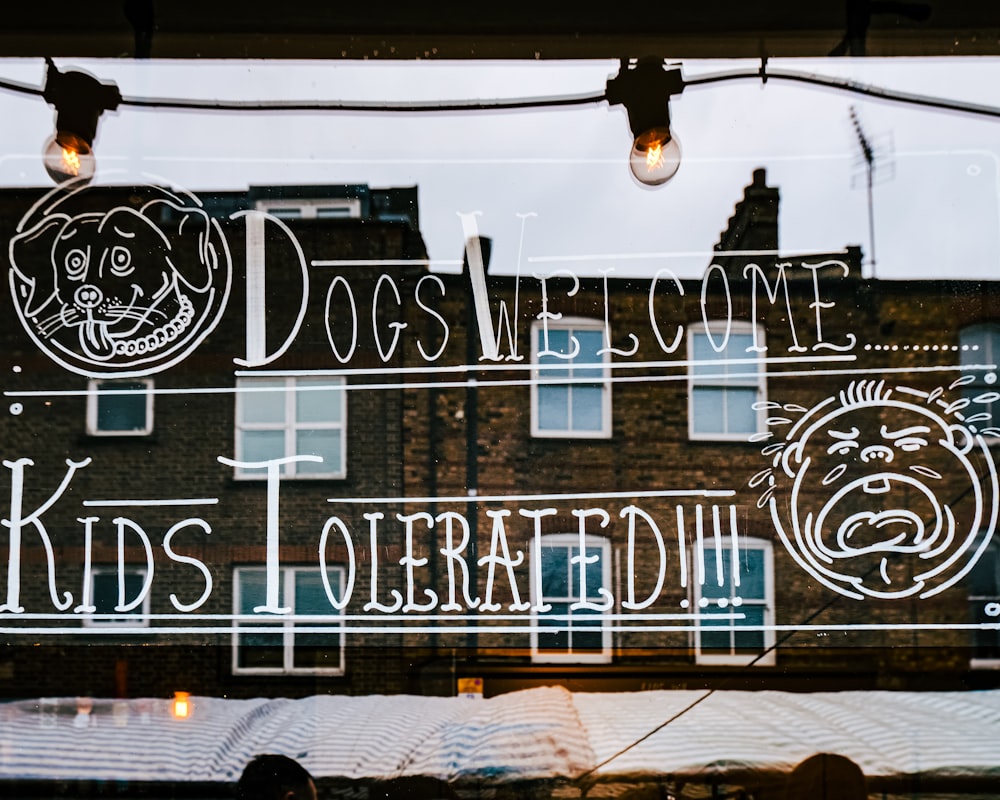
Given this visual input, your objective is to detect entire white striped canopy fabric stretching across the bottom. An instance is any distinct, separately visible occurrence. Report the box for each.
[0,687,1000,783]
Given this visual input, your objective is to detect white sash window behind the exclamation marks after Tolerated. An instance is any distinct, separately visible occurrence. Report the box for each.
[689,536,777,667]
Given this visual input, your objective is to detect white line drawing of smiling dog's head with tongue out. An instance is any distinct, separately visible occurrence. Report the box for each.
[10,187,229,374]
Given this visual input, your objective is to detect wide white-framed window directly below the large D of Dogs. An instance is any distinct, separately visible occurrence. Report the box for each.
[233,375,348,481]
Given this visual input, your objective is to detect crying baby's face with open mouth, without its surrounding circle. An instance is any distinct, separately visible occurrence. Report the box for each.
[783,401,976,595]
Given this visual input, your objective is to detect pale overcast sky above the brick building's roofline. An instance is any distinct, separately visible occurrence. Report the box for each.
[0,58,1000,279]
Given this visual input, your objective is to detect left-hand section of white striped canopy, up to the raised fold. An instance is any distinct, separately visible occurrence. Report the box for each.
[0,688,593,782]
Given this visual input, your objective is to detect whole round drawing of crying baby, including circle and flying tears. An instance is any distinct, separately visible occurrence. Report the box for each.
[751,381,997,598]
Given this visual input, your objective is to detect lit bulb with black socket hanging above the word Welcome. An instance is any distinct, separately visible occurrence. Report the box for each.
[605,59,684,186]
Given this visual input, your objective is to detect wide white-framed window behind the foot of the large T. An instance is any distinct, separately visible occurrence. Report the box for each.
[231,565,346,677]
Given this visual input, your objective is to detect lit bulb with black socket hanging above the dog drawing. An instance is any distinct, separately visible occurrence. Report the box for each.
[42,61,121,183]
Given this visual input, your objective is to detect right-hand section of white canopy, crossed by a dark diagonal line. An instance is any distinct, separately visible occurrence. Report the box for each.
[573,691,1000,782]
